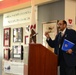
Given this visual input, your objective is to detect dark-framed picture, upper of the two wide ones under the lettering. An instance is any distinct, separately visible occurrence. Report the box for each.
[13,27,23,42]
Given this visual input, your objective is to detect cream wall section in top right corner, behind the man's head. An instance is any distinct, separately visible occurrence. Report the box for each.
[64,0,76,30]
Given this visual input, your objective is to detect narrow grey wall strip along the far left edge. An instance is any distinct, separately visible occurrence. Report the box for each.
[0,15,3,75]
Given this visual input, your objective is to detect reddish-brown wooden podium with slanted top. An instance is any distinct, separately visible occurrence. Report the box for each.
[28,44,58,75]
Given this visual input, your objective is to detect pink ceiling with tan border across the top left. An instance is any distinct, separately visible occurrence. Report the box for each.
[0,0,58,14]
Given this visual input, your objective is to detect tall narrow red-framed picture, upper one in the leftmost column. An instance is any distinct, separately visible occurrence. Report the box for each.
[4,28,11,47]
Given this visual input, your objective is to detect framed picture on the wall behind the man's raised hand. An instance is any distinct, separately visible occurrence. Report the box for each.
[43,21,57,47]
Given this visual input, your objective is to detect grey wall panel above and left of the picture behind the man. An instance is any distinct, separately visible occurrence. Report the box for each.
[38,0,64,43]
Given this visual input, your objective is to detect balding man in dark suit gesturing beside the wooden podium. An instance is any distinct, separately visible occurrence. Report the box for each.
[45,20,76,75]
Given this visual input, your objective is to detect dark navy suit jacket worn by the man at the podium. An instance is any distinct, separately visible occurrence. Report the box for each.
[46,29,76,66]
